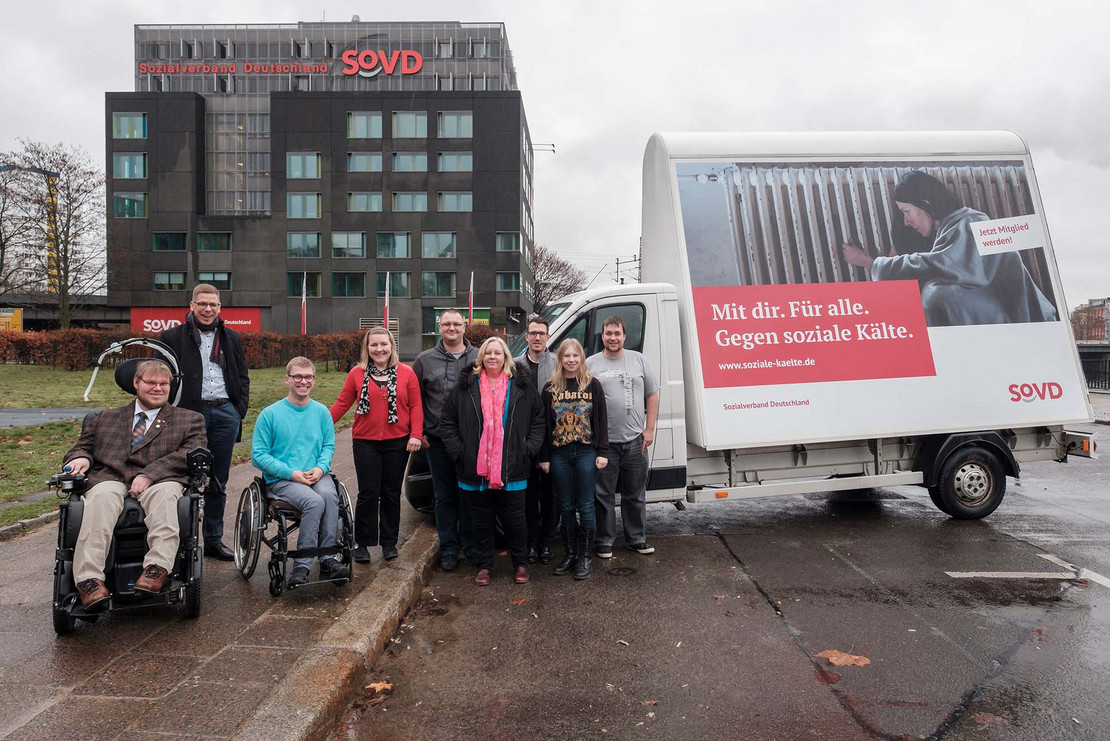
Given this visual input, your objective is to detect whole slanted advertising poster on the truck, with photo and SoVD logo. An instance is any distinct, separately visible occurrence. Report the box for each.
[675,160,1088,448]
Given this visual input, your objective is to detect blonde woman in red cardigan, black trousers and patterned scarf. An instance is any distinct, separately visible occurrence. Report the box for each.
[332,327,424,564]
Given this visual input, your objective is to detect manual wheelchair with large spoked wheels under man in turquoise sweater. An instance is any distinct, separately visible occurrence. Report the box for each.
[234,474,354,597]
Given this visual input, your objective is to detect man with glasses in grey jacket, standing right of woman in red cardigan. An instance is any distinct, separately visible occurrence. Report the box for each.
[413,308,478,571]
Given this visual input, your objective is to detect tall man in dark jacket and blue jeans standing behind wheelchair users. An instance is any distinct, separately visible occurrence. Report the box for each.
[159,283,251,561]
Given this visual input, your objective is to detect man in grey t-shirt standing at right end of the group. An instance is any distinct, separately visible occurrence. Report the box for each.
[586,316,659,558]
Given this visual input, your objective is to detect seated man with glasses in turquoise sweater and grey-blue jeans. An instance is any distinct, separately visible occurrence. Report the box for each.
[251,357,347,587]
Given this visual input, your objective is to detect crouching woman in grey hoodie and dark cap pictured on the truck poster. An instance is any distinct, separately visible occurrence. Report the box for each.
[840,170,1058,327]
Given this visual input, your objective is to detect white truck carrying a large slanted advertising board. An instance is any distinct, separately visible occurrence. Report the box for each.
[523,132,1094,519]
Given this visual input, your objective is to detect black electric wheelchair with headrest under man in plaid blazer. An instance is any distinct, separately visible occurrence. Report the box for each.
[48,338,212,636]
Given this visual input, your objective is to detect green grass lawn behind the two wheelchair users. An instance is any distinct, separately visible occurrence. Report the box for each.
[0,365,351,526]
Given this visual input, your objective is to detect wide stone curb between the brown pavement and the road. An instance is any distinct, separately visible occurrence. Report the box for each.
[233,514,440,741]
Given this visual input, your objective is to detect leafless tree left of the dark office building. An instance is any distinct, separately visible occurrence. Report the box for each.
[9,140,105,329]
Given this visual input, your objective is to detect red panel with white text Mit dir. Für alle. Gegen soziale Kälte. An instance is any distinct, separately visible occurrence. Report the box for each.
[694,281,936,388]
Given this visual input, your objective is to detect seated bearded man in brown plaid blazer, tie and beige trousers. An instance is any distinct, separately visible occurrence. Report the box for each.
[63,361,208,608]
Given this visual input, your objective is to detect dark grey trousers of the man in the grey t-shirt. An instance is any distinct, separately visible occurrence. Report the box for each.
[594,435,647,548]
